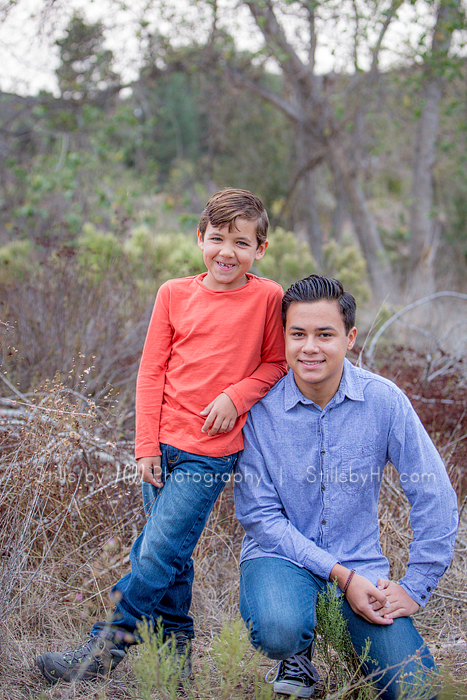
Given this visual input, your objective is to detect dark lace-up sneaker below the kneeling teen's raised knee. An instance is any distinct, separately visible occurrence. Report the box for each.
[266,644,319,698]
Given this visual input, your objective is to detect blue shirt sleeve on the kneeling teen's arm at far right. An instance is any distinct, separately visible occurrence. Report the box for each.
[388,393,457,606]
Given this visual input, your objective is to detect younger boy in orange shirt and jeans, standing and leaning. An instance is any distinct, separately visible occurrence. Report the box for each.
[37,188,286,683]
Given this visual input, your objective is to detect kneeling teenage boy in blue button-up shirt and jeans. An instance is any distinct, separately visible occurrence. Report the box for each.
[235,275,457,700]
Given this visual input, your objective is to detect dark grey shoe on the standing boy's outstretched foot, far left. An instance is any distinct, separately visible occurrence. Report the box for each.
[36,635,126,683]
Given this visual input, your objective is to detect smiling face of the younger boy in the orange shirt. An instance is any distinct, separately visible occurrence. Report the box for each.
[198,218,268,291]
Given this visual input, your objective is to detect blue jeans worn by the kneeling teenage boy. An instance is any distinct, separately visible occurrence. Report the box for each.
[240,557,436,700]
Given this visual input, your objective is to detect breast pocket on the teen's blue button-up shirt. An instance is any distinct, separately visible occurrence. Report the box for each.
[339,443,383,496]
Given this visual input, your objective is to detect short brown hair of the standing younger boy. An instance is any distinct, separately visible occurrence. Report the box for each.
[198,187,269,245]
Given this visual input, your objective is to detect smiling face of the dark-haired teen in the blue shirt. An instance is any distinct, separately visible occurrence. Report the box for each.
[285,299,357,408]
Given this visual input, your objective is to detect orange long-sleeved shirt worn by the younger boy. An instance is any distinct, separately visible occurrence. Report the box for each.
[135,273,286,459]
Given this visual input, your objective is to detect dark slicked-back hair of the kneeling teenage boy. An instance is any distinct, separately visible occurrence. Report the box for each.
[282,275,357,335]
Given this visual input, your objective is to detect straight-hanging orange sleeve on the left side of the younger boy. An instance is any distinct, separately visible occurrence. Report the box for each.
[135,285,173,460]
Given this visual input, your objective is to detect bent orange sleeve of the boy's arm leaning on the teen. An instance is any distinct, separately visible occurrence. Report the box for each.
[223,288,287,416]
